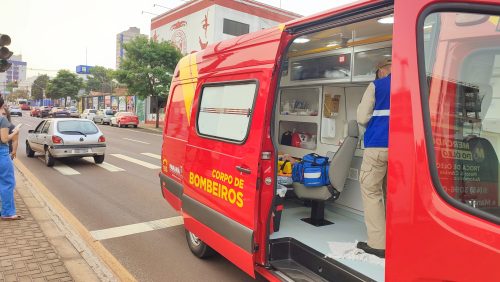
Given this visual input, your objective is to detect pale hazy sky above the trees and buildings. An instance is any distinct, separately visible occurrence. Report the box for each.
[0,0,354,77]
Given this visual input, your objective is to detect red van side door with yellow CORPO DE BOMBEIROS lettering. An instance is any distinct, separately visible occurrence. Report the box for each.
[182,28,290,277]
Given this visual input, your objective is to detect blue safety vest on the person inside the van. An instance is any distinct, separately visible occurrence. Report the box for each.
[364,75,391,148]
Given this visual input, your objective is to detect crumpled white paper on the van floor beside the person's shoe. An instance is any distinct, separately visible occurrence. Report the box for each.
[326,241,385,267]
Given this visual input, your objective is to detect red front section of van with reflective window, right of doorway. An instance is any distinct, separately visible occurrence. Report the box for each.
[386,0,500,281]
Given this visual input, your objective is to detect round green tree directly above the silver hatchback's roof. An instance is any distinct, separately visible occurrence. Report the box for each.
[46,70,83,106]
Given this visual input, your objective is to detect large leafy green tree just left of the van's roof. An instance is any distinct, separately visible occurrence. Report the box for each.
[116,36,182,128]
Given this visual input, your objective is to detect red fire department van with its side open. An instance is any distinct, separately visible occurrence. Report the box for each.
[160,0,500,281]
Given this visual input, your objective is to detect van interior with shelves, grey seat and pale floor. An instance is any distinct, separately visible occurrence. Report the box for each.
[269,13,393,281]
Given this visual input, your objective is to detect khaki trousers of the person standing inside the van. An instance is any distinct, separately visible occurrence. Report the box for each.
[359,148,387,249]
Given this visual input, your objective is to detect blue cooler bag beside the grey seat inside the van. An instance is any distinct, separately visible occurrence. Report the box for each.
[292,153,330,187]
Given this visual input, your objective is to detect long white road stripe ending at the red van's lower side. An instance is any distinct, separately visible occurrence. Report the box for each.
[90,216,184,241]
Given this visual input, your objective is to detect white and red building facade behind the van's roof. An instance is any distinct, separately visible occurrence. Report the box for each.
[151,0,301,54]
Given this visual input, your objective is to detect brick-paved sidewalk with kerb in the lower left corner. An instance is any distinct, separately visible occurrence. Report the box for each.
[0,169,100,282]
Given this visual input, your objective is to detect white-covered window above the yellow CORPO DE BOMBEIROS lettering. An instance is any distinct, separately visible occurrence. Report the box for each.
[197,81,257,143]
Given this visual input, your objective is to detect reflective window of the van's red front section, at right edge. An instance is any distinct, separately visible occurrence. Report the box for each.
[420,9,500,222]
